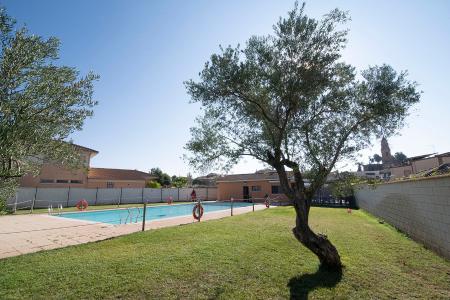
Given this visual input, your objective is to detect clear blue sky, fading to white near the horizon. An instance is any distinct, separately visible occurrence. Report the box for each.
[0,0,450,175]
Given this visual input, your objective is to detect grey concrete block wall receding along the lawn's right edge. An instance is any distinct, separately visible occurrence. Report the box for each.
[355,176,450,259]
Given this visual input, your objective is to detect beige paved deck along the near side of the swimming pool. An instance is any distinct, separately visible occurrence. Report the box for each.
[0,205,265,259]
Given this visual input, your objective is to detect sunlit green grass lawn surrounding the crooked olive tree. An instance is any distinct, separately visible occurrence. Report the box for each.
[0,207,450,299]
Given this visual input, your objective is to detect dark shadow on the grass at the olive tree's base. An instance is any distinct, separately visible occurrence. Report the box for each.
[287,268,342,299]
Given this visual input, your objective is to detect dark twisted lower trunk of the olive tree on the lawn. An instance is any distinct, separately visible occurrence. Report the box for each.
[292,213,342,270]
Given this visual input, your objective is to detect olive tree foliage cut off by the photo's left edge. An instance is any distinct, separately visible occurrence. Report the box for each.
[0,7,97,204]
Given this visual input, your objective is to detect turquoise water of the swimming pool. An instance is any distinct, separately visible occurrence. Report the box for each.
[60,202,252,224]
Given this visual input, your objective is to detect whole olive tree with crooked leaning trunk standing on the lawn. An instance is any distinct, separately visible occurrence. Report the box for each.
[185,4,420,269]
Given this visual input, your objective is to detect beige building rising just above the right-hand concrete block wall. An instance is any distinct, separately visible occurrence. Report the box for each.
[390,152,450,178]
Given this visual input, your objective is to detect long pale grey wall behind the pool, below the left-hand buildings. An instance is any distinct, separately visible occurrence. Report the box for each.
[8,187,217,211]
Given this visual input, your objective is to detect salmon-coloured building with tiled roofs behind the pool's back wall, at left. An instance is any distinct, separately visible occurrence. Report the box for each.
[20,144,154,188]
